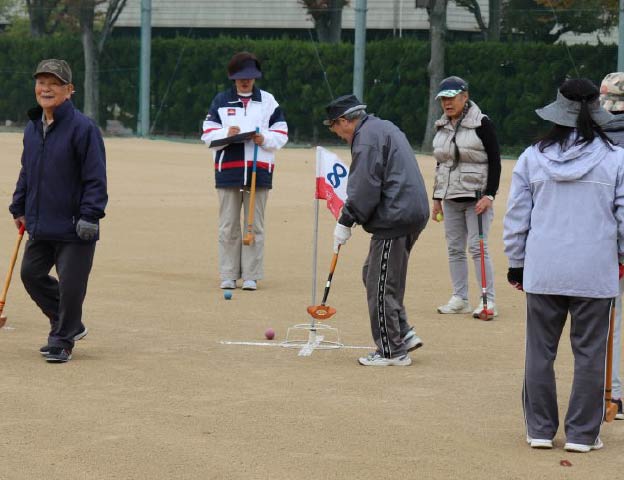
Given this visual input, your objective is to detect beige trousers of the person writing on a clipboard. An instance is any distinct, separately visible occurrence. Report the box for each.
[217,187,269,280]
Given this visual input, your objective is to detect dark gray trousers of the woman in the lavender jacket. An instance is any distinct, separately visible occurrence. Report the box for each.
[523,293,612,445]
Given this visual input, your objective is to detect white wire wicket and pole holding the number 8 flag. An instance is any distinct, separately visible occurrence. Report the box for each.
[282,154,343,357]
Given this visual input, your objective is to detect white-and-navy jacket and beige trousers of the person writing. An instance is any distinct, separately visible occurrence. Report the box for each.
[201,87,288,280]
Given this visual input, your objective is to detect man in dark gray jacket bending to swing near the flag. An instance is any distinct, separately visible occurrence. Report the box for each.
[324,95,429,366]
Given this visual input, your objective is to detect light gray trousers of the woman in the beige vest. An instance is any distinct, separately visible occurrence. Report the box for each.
[444,200,495,302]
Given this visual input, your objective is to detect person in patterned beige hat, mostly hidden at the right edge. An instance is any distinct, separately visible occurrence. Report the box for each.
[600,72,624,420]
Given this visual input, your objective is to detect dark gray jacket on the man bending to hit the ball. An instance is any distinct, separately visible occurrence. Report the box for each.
[339,115,429,239]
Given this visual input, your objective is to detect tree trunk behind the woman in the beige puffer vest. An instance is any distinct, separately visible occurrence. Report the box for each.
[422,0,448,152]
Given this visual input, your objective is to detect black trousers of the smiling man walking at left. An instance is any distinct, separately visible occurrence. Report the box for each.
[20,239,95,349]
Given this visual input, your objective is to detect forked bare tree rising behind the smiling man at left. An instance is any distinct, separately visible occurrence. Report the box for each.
[66,0,127,123]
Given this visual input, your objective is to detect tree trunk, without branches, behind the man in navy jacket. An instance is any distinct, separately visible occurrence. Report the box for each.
[79,0,100,124]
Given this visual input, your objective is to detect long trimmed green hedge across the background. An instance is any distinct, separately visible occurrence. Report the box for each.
[0,35,617,147]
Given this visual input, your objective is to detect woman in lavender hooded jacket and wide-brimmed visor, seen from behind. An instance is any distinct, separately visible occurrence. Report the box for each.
[503,79,624,452]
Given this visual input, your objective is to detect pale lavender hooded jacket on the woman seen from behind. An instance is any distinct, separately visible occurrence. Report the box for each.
[503,138,624,298]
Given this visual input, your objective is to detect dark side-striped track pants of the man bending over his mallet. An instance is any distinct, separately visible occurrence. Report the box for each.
[362,233,418,358]
